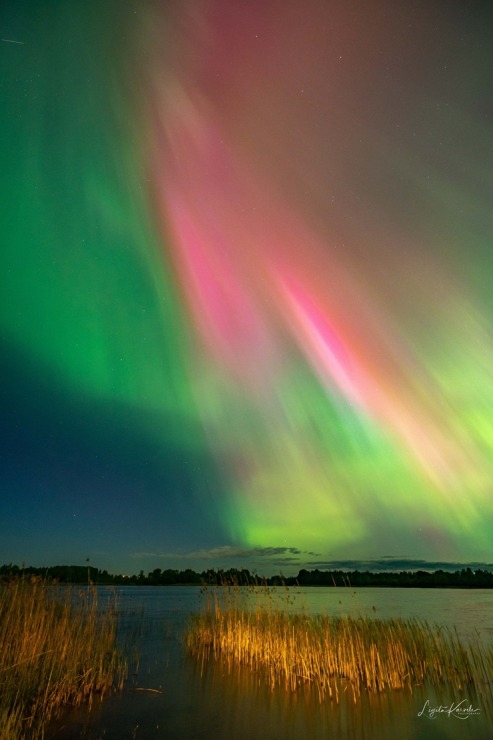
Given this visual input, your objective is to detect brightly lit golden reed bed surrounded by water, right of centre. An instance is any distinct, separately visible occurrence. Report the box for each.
[186,587,493,703]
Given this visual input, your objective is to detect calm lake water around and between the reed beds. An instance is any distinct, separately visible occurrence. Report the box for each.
[49,586,493,740]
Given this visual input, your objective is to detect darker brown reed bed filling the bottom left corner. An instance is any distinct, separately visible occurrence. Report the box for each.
[0,577,125,740]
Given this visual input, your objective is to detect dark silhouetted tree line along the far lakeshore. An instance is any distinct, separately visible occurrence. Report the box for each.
[0,563,493,588]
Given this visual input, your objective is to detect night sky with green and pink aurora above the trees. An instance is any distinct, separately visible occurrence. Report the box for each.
[0,0,493,575]
